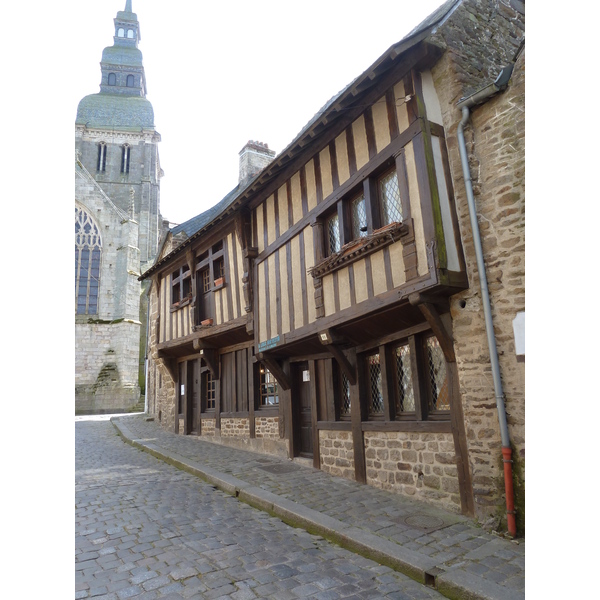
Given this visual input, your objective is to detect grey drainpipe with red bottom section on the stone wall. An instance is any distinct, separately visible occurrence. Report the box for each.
[457,58,520,537]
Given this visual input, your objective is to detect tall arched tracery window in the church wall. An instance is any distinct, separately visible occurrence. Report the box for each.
[75,206,102,315]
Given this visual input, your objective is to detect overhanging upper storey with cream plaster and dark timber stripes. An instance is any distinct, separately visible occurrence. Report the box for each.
[143,0,496,354]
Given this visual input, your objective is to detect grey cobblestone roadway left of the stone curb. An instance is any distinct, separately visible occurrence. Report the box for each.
[75,419,442,600]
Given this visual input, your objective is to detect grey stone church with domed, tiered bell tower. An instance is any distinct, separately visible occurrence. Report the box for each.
[75,0,163,414]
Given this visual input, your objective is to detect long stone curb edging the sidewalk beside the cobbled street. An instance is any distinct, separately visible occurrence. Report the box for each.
[110,417,521,600]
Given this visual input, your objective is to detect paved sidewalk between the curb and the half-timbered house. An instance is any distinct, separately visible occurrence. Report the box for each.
[109,415,525,599]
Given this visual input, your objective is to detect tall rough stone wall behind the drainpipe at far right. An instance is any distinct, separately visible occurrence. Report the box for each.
[432,0,525,533]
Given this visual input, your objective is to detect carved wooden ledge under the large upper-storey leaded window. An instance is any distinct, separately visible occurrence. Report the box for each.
[308,222,410,278]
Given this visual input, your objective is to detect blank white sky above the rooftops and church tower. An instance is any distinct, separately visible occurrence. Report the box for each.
[69,0,443,223]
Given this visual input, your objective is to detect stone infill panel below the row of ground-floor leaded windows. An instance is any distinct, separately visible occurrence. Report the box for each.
[364,431,461,512]
